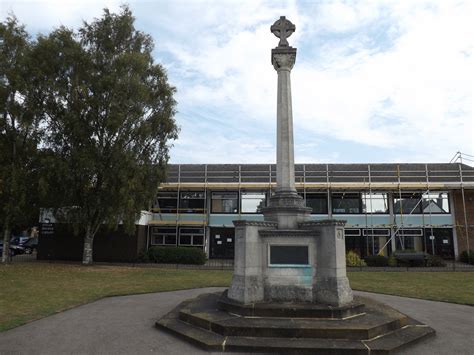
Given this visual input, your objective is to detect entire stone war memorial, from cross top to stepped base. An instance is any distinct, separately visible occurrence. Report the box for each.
[156,16,435,354]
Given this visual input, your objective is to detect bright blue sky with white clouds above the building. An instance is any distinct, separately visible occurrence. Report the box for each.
[0,0,474,165]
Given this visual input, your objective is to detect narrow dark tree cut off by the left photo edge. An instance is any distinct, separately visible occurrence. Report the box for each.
[0,17,41,263]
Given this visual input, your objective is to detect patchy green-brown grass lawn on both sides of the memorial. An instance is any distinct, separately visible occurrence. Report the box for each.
[0,263,474,331]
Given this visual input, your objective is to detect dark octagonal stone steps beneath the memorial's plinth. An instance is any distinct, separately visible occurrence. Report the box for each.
[156,292,435,355]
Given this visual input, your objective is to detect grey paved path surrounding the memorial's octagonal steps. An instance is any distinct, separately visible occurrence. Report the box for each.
[0,288,474,355]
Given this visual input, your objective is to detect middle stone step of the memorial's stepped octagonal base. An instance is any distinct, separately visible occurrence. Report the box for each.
[178,295,409,340]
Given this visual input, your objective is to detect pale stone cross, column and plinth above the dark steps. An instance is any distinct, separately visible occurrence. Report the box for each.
[228,17,352,306]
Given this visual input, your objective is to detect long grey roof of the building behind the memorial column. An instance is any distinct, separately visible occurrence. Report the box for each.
[164,163,474,188]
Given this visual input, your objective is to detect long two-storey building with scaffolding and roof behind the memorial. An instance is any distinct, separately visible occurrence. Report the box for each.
[147,163,474,259]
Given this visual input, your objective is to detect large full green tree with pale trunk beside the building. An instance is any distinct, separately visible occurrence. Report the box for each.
[34,7,178,264]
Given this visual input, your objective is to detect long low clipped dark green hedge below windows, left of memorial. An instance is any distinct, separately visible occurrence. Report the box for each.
[143,247,206,265]
